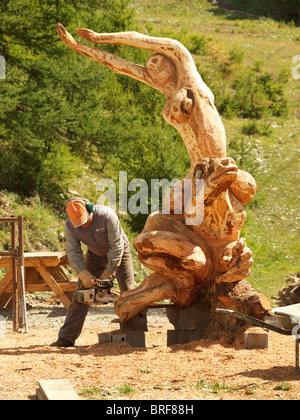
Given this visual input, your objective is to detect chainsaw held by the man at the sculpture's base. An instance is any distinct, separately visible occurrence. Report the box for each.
[76,279,113,305]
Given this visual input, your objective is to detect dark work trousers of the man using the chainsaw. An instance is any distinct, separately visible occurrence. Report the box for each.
[58,244,135,344]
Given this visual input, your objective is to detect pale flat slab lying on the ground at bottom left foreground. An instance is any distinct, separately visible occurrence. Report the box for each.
[37,379,81,401]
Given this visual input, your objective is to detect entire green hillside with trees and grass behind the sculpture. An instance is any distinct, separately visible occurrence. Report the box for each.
[0,0,300,298]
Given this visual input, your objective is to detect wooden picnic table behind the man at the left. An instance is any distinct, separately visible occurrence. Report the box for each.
[0,252,77,309]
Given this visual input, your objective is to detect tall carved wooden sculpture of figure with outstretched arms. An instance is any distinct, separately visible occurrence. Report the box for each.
[57,24,270,321]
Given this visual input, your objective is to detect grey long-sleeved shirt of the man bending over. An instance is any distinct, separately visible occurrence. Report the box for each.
[65,205,129,273]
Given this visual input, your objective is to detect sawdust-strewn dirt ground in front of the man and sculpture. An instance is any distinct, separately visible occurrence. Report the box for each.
[0,303,300,400]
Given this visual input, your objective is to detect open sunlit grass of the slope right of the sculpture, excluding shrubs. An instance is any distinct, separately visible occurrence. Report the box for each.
[135,0,300,298]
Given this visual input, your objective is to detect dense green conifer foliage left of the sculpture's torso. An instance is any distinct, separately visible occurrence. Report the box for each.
[0,0,190,213]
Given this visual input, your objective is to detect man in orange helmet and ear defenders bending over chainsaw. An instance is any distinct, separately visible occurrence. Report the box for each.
[52,198,135,347]
